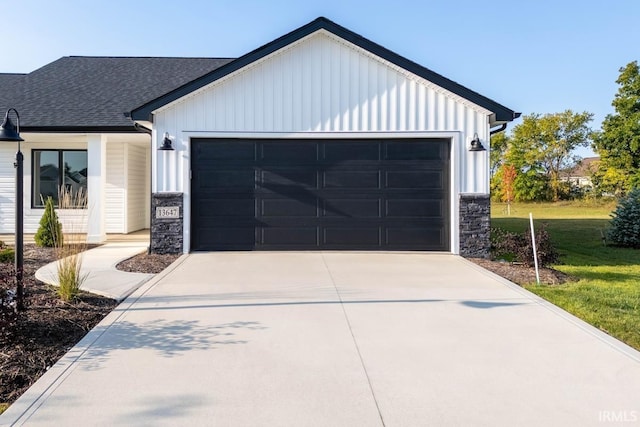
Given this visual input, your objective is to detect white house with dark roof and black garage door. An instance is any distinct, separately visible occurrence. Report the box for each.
[0,18,519,256]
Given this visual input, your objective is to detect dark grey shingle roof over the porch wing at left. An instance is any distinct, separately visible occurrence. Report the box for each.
[0,56,231,131]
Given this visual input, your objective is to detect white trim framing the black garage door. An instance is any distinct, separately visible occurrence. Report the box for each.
[179,131,463,255]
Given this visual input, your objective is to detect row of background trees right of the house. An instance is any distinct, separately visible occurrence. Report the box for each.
[490,61,640,202]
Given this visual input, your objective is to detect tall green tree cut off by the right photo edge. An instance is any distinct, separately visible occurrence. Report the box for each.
[593,61,640,195]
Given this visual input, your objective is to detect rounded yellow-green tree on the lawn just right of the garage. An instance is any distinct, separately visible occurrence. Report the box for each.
[505,110,593,201]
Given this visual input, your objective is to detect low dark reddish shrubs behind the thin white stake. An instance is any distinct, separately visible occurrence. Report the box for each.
[491,226,560,267]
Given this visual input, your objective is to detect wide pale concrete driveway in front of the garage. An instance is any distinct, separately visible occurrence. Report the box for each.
[5,252,640,427]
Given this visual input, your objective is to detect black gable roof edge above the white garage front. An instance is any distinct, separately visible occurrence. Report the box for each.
[131,17,520,124]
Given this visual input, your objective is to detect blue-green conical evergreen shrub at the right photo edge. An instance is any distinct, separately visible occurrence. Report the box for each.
[607,188,640,249]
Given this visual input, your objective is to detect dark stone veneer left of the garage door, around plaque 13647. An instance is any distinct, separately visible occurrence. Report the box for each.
[150,193,184,254]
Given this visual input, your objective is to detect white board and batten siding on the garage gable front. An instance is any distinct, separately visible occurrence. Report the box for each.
[152,30,491,196]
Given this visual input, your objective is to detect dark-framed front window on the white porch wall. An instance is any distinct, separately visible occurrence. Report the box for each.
[31,150,87,207]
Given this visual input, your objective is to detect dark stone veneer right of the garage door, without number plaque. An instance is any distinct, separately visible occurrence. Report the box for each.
[460,194,491,258]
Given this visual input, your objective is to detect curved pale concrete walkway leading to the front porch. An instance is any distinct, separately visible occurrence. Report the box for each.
[36,240,154,301]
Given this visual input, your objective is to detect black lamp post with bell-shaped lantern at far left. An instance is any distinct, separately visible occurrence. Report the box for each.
[0,108,24,311]
